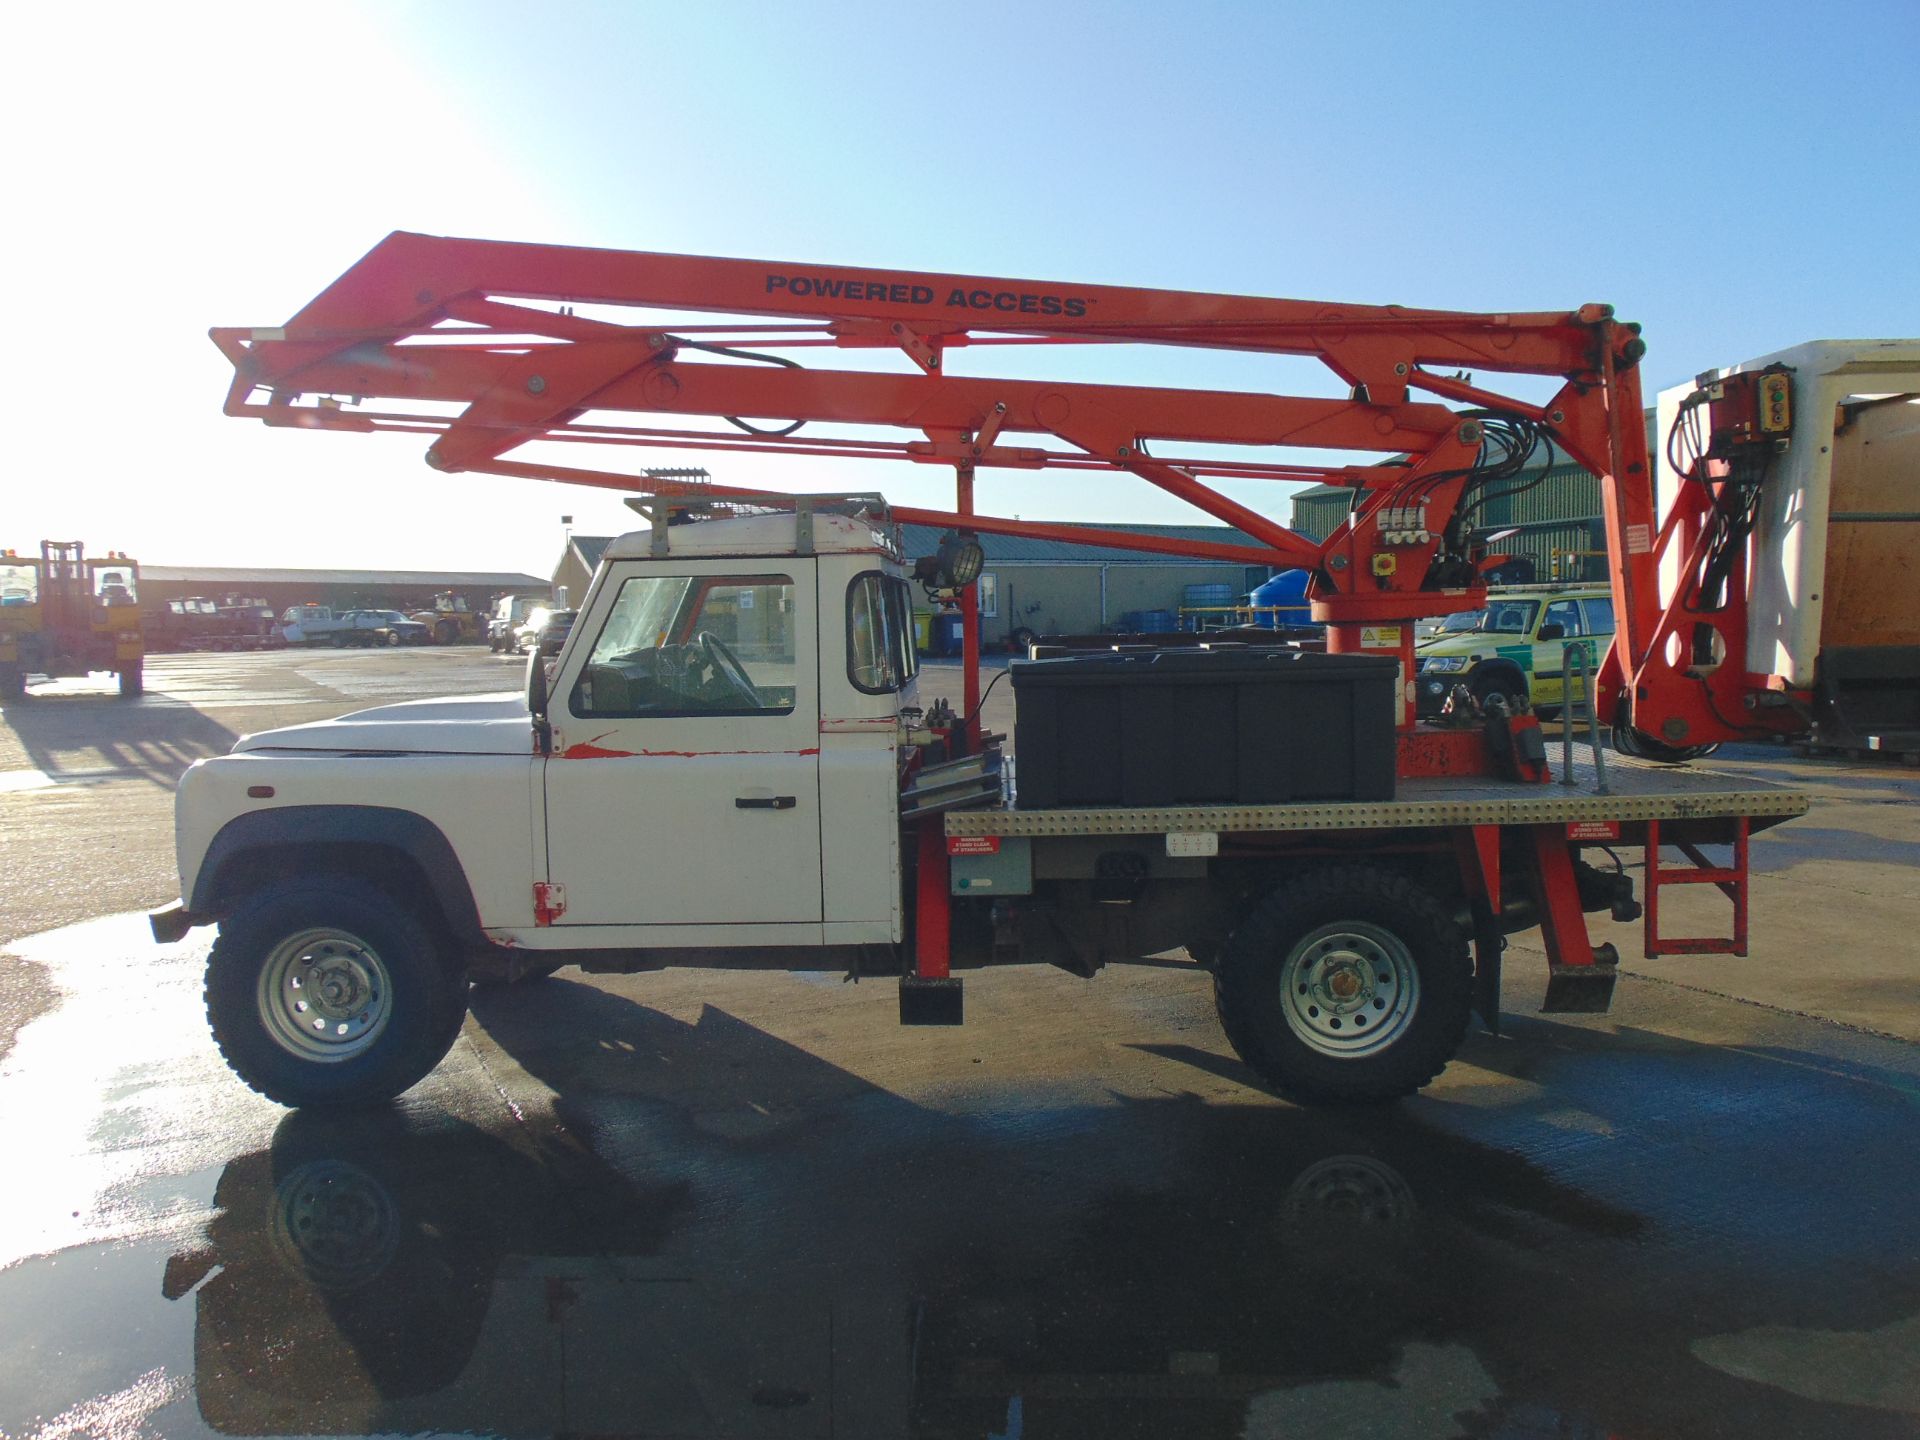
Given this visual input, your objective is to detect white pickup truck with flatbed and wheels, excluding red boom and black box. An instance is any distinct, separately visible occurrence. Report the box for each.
[152,505,1807,1106]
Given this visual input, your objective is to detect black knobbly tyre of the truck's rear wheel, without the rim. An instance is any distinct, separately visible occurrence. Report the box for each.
[1213,864,1473,1104]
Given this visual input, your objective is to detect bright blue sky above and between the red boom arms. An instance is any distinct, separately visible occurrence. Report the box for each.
[0,0,1920,570]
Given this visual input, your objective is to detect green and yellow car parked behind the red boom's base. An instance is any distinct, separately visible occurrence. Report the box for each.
[1413,586,1613,716]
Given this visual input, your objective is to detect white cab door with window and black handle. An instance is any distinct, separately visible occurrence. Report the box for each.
[545,557,822,945]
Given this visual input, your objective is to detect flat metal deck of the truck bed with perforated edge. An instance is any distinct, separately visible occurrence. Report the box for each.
[947,755,1811,835]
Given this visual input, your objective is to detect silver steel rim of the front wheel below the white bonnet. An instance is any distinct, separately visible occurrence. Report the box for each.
[255,929,394,1066]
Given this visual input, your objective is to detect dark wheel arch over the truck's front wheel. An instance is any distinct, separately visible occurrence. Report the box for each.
[186,804,488,948]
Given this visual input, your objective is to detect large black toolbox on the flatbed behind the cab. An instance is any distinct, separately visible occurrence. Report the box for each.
[1008,647,1400,810]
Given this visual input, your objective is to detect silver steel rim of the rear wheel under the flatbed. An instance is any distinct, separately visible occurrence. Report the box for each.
[1281,920,1421,1060]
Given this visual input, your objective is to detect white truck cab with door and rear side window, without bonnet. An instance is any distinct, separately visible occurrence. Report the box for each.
[537,515,916,947]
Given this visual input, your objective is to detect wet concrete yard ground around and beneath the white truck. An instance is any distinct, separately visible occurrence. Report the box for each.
[0,651,1920,1440]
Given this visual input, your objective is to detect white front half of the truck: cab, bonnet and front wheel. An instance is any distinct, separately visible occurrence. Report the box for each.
[154,505,916,1106]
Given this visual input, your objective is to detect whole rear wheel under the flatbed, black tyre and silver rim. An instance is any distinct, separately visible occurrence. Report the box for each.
[1213,864,1473,1104]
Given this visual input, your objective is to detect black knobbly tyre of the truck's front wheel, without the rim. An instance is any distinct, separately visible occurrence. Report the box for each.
[205,876,467,1110]
